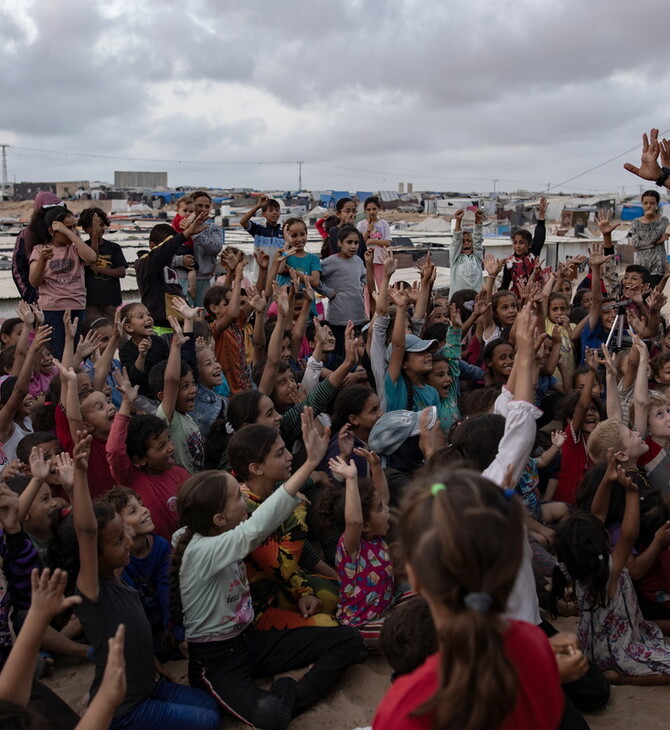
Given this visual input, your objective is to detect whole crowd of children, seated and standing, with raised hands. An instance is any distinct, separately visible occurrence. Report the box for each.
[0,134,670,730]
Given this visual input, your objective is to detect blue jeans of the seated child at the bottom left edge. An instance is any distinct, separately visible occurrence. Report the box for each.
[110,681,221,730]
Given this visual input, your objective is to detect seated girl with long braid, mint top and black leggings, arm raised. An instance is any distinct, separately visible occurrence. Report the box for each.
[172,409,365,730]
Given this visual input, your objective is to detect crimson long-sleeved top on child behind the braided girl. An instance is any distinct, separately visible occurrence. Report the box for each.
[107,413,190,540]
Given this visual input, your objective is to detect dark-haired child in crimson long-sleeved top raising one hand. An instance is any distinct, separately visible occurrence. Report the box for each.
[107,369,189,539]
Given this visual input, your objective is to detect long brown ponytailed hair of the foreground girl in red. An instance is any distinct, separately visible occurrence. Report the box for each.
[400,469,523,730]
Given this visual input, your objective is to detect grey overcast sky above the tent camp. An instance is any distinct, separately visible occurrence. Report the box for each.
[0,0,670,192]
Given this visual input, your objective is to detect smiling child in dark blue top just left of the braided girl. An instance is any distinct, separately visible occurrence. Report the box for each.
[104,487,183,662]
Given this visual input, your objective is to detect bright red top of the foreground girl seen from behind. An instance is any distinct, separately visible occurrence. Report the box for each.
[372,621,563,730]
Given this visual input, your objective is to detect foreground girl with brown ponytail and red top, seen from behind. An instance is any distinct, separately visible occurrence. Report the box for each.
[372,469,563,730]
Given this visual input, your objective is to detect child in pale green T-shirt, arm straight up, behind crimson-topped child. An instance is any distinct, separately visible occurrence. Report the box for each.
[149,306,205,474]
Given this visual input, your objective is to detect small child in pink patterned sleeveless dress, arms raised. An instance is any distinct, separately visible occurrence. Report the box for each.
[328,449,402,649]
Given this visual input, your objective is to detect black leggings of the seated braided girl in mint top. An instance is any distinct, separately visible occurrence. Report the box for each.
[188,626,367,730]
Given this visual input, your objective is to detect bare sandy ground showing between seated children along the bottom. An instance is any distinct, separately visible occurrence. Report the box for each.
[39,619,670,730]
